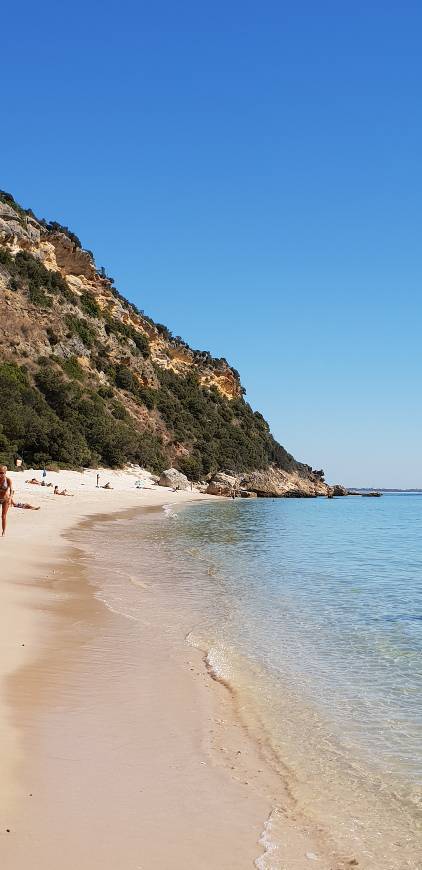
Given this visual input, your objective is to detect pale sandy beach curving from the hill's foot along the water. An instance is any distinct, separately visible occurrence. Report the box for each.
[0,469,340,870]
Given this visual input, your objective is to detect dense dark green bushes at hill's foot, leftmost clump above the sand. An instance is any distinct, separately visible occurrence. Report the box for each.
[0,361,166,470]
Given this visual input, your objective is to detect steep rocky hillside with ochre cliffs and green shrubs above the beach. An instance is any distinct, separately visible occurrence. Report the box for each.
[0,192,326,495]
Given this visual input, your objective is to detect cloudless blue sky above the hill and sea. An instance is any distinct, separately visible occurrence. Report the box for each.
[0,0,422,487]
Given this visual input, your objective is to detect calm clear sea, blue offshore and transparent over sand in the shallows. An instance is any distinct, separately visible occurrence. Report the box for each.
[80,494,422,870]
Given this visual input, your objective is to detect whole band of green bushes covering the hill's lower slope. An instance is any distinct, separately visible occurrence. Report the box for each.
[0,358,294,479]
